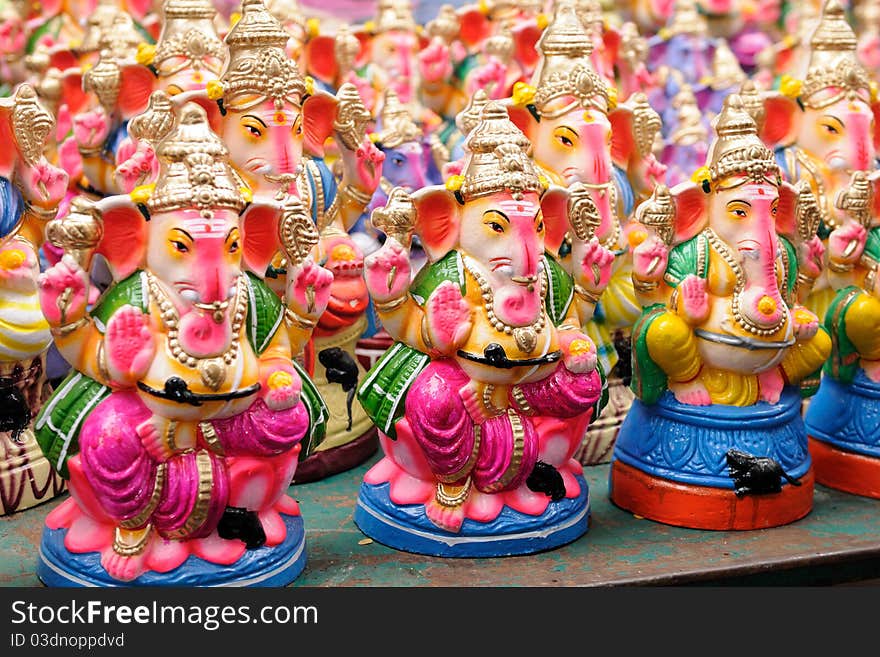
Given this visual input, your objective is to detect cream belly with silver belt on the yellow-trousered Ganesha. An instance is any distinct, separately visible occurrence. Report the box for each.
[694,301,793,374]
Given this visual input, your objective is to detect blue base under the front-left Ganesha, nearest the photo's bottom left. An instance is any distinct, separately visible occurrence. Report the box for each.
[37,514,306,587]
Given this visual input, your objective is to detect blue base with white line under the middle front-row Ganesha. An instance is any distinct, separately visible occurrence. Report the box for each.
[354,476,590,557]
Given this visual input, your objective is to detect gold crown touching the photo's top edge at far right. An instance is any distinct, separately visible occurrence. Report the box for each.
[800,0,871,109]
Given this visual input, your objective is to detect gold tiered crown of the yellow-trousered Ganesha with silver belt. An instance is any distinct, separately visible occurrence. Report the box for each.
[706,94,780,190]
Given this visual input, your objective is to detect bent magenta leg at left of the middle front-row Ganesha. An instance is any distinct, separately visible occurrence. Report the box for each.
[406,360,478,483]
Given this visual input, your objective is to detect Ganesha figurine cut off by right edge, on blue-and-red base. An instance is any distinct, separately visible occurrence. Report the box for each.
[804,171,880,498]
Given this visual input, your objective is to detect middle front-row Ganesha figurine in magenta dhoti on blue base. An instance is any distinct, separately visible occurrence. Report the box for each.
[355,102,607,556]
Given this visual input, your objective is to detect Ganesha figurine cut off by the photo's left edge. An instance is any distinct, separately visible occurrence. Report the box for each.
[0,84,67,515]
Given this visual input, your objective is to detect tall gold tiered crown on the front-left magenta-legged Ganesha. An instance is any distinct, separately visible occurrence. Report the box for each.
[147,103,247,216]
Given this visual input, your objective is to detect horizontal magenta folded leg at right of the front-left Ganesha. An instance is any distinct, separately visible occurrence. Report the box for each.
[209,399,309,456]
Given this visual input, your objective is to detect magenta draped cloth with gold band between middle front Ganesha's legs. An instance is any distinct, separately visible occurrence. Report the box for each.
[473,409,538,493]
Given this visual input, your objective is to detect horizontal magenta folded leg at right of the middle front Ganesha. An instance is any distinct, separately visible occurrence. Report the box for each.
[511,363,602,417]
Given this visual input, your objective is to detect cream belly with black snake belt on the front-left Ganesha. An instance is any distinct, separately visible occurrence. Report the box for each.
[138,339,259,421]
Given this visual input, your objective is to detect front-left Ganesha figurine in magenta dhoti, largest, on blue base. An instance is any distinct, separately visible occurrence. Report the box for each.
[36,103,320,585]
